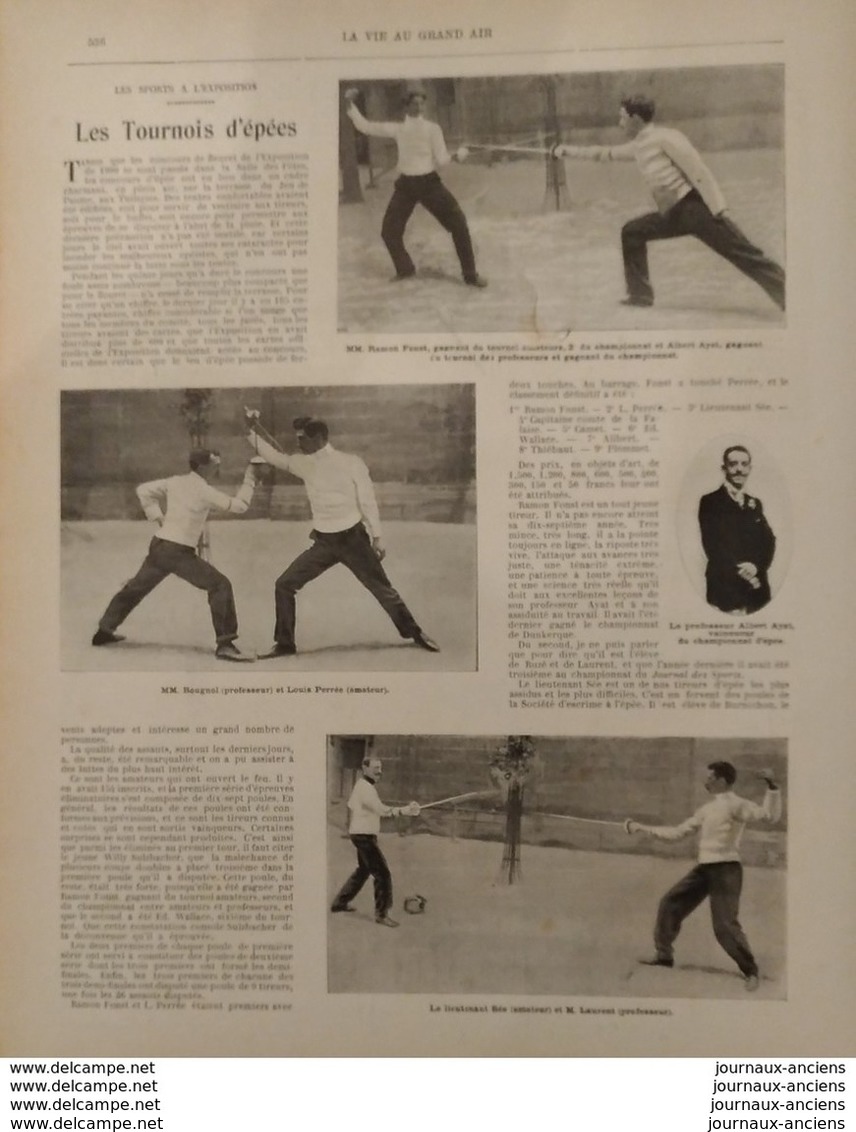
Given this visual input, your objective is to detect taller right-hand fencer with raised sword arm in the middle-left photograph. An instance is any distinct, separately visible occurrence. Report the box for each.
[247,410,439,660]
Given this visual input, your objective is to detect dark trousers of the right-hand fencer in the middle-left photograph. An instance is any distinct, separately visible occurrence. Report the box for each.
[274,523,419,649]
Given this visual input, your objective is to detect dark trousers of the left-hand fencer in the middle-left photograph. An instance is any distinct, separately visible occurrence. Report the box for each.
[99,535,238,644]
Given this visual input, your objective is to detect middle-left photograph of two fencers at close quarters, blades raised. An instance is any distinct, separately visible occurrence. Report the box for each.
[60,384,478,675]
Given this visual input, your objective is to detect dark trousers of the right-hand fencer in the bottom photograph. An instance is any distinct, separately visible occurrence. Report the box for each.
[654,860,757,975]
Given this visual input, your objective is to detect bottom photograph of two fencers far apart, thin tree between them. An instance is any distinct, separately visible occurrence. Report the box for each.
[327,735,787,1001]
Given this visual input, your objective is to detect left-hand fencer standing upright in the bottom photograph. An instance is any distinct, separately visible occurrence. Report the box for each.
[329,755,425,927]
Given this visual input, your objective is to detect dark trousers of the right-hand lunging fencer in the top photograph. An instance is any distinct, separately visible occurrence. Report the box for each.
[622,189,785,310]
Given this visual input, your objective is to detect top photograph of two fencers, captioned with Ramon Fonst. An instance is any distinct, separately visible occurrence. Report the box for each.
[339,63,786,334]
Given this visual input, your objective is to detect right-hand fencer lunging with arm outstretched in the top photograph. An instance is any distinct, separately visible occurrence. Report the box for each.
[553,94,785,310]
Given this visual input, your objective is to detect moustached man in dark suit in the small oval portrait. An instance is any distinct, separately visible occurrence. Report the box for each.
[699,445,776,614]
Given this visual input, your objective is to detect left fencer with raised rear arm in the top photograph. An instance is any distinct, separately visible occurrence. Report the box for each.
[344,87,487,288]
